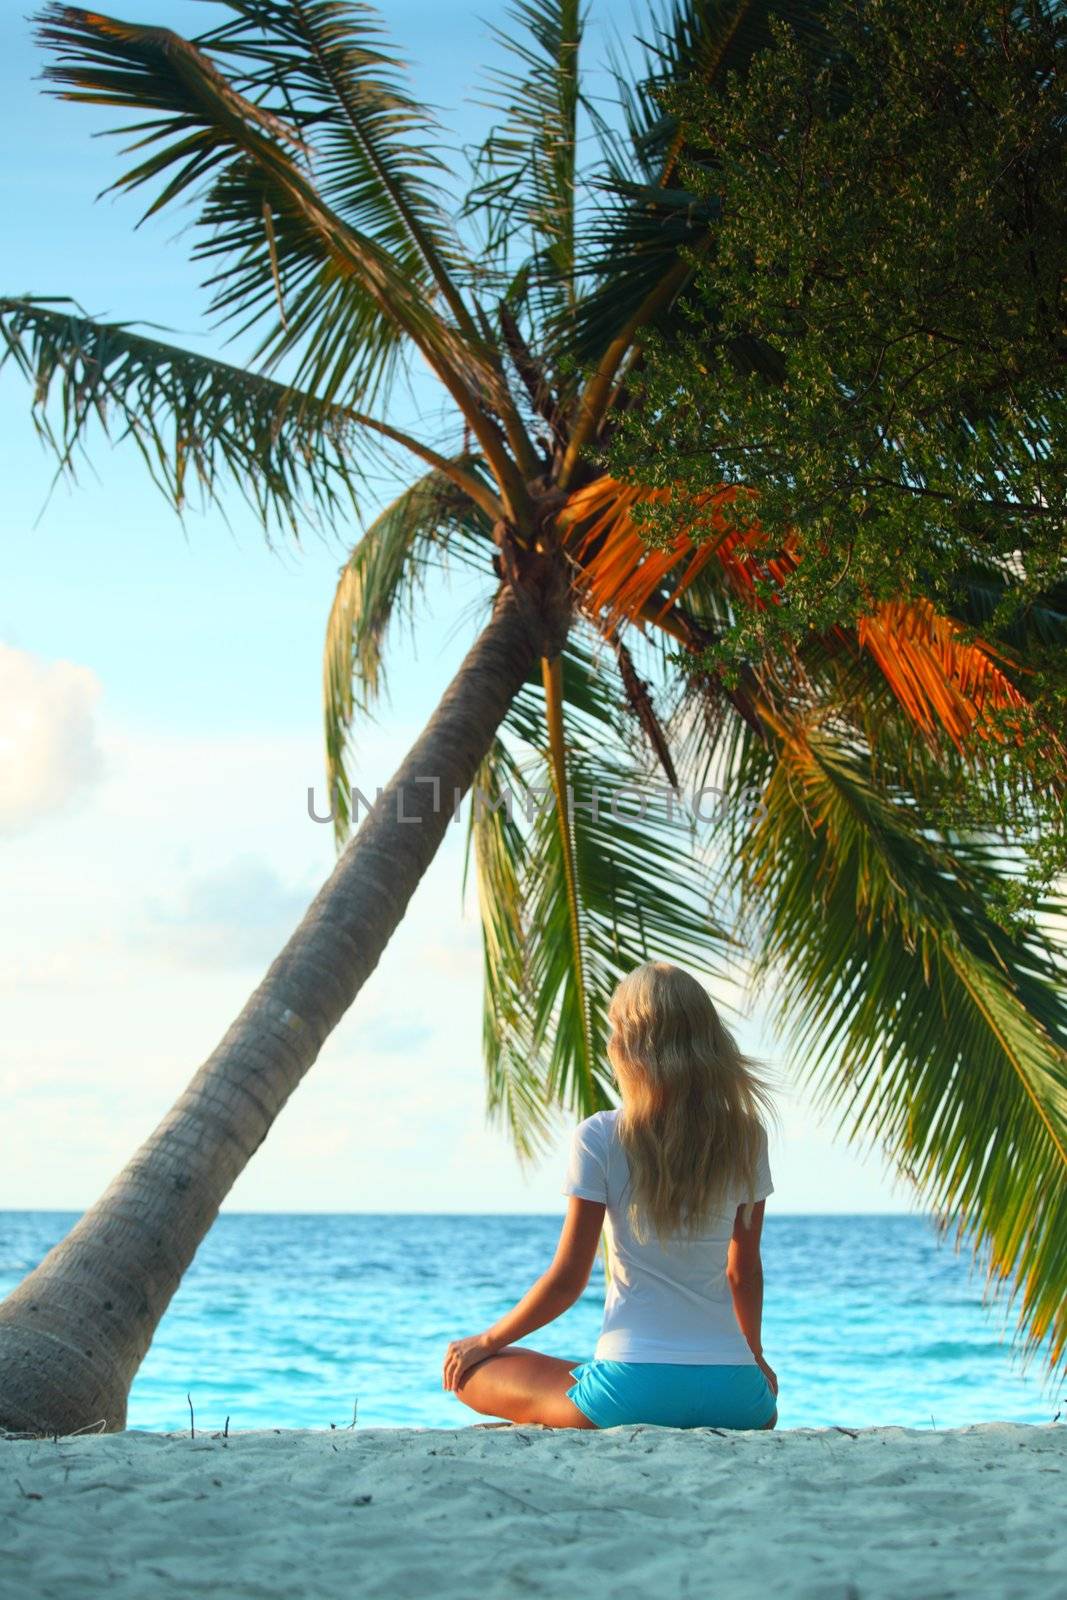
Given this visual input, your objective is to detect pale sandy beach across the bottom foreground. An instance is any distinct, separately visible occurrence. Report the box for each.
[0,1422,1067,1600]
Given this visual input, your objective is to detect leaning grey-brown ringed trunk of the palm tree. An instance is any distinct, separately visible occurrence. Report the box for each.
[0,576,569,1434]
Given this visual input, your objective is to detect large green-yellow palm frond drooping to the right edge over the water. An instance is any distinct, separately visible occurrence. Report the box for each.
[736,722,1067,1365]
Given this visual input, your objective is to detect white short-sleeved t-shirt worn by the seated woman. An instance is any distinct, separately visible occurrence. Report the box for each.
[563,1110,774,1365]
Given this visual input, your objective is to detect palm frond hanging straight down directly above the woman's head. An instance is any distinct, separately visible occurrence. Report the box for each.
[463,637,731,1142]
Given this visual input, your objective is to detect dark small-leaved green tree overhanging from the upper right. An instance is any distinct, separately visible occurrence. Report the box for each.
[611,0,1067,909]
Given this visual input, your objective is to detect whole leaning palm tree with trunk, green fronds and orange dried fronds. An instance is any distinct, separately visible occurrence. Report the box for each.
[0,0,1067,1432]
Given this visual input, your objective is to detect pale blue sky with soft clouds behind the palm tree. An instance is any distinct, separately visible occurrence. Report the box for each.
[0,0,912,1211]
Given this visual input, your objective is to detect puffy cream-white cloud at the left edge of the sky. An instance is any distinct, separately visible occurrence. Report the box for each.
[0,645,104,834]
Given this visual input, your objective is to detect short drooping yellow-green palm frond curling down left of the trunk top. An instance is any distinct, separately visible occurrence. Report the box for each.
[323,458,496,846]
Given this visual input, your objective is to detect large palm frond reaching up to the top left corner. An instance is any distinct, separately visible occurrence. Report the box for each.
[38,0,489,403]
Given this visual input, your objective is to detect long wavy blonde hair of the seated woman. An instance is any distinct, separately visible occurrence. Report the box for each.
[608,962,777,1243]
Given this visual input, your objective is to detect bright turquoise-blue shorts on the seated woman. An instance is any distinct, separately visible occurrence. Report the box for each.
[566,1360,777,1427]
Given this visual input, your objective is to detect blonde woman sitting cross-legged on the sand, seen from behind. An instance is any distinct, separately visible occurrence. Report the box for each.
[445,962,777,1429]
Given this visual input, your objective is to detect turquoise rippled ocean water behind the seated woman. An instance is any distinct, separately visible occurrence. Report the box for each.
[0,1211,1067,1432]
